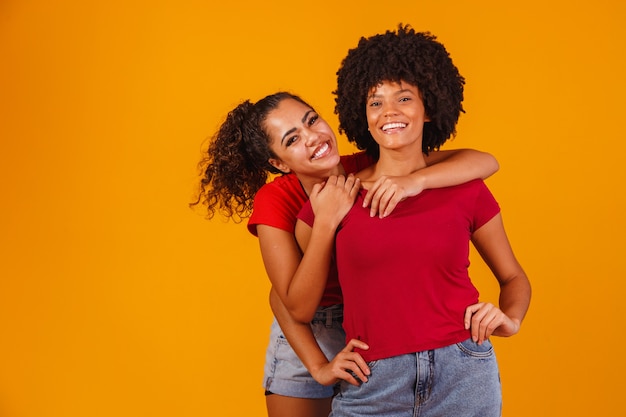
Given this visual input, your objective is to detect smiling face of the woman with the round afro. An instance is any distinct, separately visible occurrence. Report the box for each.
[366,81,429,152]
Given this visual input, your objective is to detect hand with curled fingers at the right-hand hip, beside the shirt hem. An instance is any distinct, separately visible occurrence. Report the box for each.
[465,303,521,344]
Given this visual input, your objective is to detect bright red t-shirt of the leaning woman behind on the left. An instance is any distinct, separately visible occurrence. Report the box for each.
[248,152,373,306]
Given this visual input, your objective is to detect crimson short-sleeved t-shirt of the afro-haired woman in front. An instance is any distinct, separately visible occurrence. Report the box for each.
[299,180,500,361]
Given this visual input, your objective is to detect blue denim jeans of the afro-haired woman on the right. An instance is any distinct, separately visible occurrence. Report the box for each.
[330,339,502,417]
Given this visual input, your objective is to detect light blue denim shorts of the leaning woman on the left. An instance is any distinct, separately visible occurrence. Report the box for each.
[263,305,346,398]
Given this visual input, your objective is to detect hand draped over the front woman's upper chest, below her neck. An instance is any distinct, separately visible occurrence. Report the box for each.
[363,173,424,219]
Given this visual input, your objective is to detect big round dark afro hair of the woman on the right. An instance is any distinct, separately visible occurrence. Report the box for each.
[333,24,465,158]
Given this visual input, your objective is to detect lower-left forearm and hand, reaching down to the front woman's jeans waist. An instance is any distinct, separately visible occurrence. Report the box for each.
[270,290,370,385]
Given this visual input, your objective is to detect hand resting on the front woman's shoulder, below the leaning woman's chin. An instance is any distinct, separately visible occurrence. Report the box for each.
[309,174,361,228]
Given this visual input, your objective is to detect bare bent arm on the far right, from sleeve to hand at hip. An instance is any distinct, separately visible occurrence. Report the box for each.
[465,214,531,343]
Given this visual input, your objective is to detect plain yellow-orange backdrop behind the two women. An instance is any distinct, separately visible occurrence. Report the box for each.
[0,0,626,417]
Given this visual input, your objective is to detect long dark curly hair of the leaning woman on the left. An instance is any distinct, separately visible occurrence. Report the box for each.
[189,92,312,223]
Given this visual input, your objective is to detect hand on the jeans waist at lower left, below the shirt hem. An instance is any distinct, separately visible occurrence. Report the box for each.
[312,339,370,386]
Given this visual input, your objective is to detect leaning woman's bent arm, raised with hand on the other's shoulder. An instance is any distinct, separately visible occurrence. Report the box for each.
[257,176,360,323]
